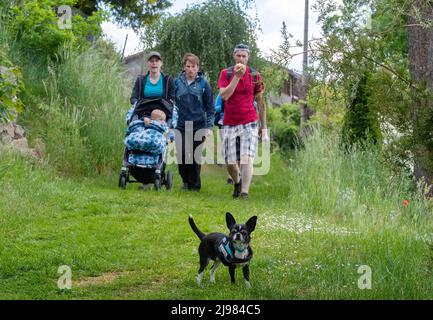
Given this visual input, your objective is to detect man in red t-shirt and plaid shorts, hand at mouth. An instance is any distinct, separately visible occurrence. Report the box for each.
[218,44,268,199]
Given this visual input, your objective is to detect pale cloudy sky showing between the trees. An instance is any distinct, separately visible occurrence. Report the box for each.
[102,0,321,70]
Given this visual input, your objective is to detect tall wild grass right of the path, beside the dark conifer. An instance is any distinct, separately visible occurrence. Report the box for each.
[289,131,433,231]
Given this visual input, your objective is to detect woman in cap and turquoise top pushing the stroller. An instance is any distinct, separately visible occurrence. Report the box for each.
[130,51,175,105]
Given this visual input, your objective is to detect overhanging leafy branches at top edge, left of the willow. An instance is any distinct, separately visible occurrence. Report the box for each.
[74,0,172,30]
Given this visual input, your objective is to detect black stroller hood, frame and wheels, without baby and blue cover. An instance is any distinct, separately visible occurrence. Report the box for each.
[119,98,173,191]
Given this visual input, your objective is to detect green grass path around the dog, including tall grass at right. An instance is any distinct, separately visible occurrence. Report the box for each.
[0,132,433,299]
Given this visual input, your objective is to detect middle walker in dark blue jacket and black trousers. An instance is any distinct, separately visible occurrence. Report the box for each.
[175,53,215,191]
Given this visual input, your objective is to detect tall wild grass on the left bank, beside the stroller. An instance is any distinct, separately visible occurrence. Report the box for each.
[22,47,131,175]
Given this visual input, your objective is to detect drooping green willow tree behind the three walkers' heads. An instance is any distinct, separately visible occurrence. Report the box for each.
[142,0,259,88]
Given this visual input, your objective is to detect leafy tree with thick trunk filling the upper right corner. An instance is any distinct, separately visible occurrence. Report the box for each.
[314,0,433,195]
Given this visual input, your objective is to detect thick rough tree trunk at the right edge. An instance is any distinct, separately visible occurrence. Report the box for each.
[408,0,433,196]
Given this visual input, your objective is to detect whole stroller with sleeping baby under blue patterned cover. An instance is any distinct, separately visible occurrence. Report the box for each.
[119,99,174,190]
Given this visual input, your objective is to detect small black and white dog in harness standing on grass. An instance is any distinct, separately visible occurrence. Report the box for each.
[188,212,257,287]
